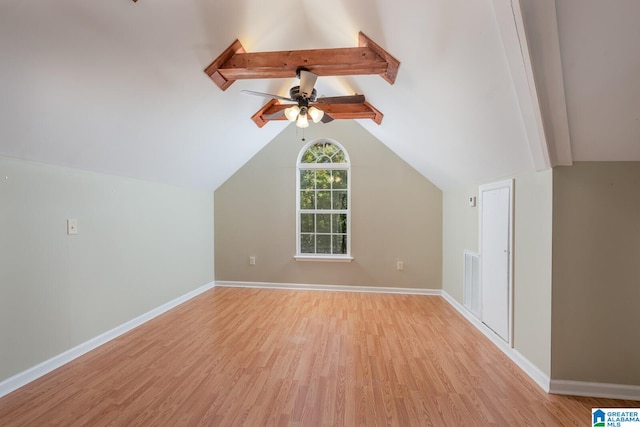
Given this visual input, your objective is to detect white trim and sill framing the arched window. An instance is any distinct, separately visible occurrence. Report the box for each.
[293,138,353,262]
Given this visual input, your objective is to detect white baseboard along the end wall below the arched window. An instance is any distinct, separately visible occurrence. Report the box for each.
[216,280,442,295]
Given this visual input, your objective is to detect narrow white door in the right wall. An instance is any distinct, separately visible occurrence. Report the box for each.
[480,180,513,343]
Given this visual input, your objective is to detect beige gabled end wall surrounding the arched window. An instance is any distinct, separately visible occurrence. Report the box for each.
[215,121,442,289]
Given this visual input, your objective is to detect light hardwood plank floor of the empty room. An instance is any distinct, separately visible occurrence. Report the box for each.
[0,287,640,426]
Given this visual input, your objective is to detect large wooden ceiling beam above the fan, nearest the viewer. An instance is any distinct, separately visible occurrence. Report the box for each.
[204,32,400,90]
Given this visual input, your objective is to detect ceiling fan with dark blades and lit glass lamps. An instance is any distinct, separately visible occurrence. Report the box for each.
[241,68,365,128]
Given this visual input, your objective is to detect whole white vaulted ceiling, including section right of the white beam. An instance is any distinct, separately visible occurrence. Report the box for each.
[0,0,640,190]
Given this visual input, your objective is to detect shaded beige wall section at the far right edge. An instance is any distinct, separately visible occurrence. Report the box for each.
[551,162,640,386]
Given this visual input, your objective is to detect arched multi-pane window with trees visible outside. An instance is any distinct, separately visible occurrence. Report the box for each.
[296,139,351,260]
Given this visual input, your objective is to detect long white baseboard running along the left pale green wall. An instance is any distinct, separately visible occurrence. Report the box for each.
[0,282,215,397]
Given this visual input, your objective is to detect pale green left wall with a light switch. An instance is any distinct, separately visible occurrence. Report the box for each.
[0,157,214,382]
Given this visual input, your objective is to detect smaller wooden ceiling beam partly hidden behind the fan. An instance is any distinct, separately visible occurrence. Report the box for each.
[251,99,383,127]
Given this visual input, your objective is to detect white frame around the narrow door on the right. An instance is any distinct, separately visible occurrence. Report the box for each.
[478,179,515,348]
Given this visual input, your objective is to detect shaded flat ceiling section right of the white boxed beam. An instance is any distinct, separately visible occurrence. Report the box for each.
[557,0,640,161]
